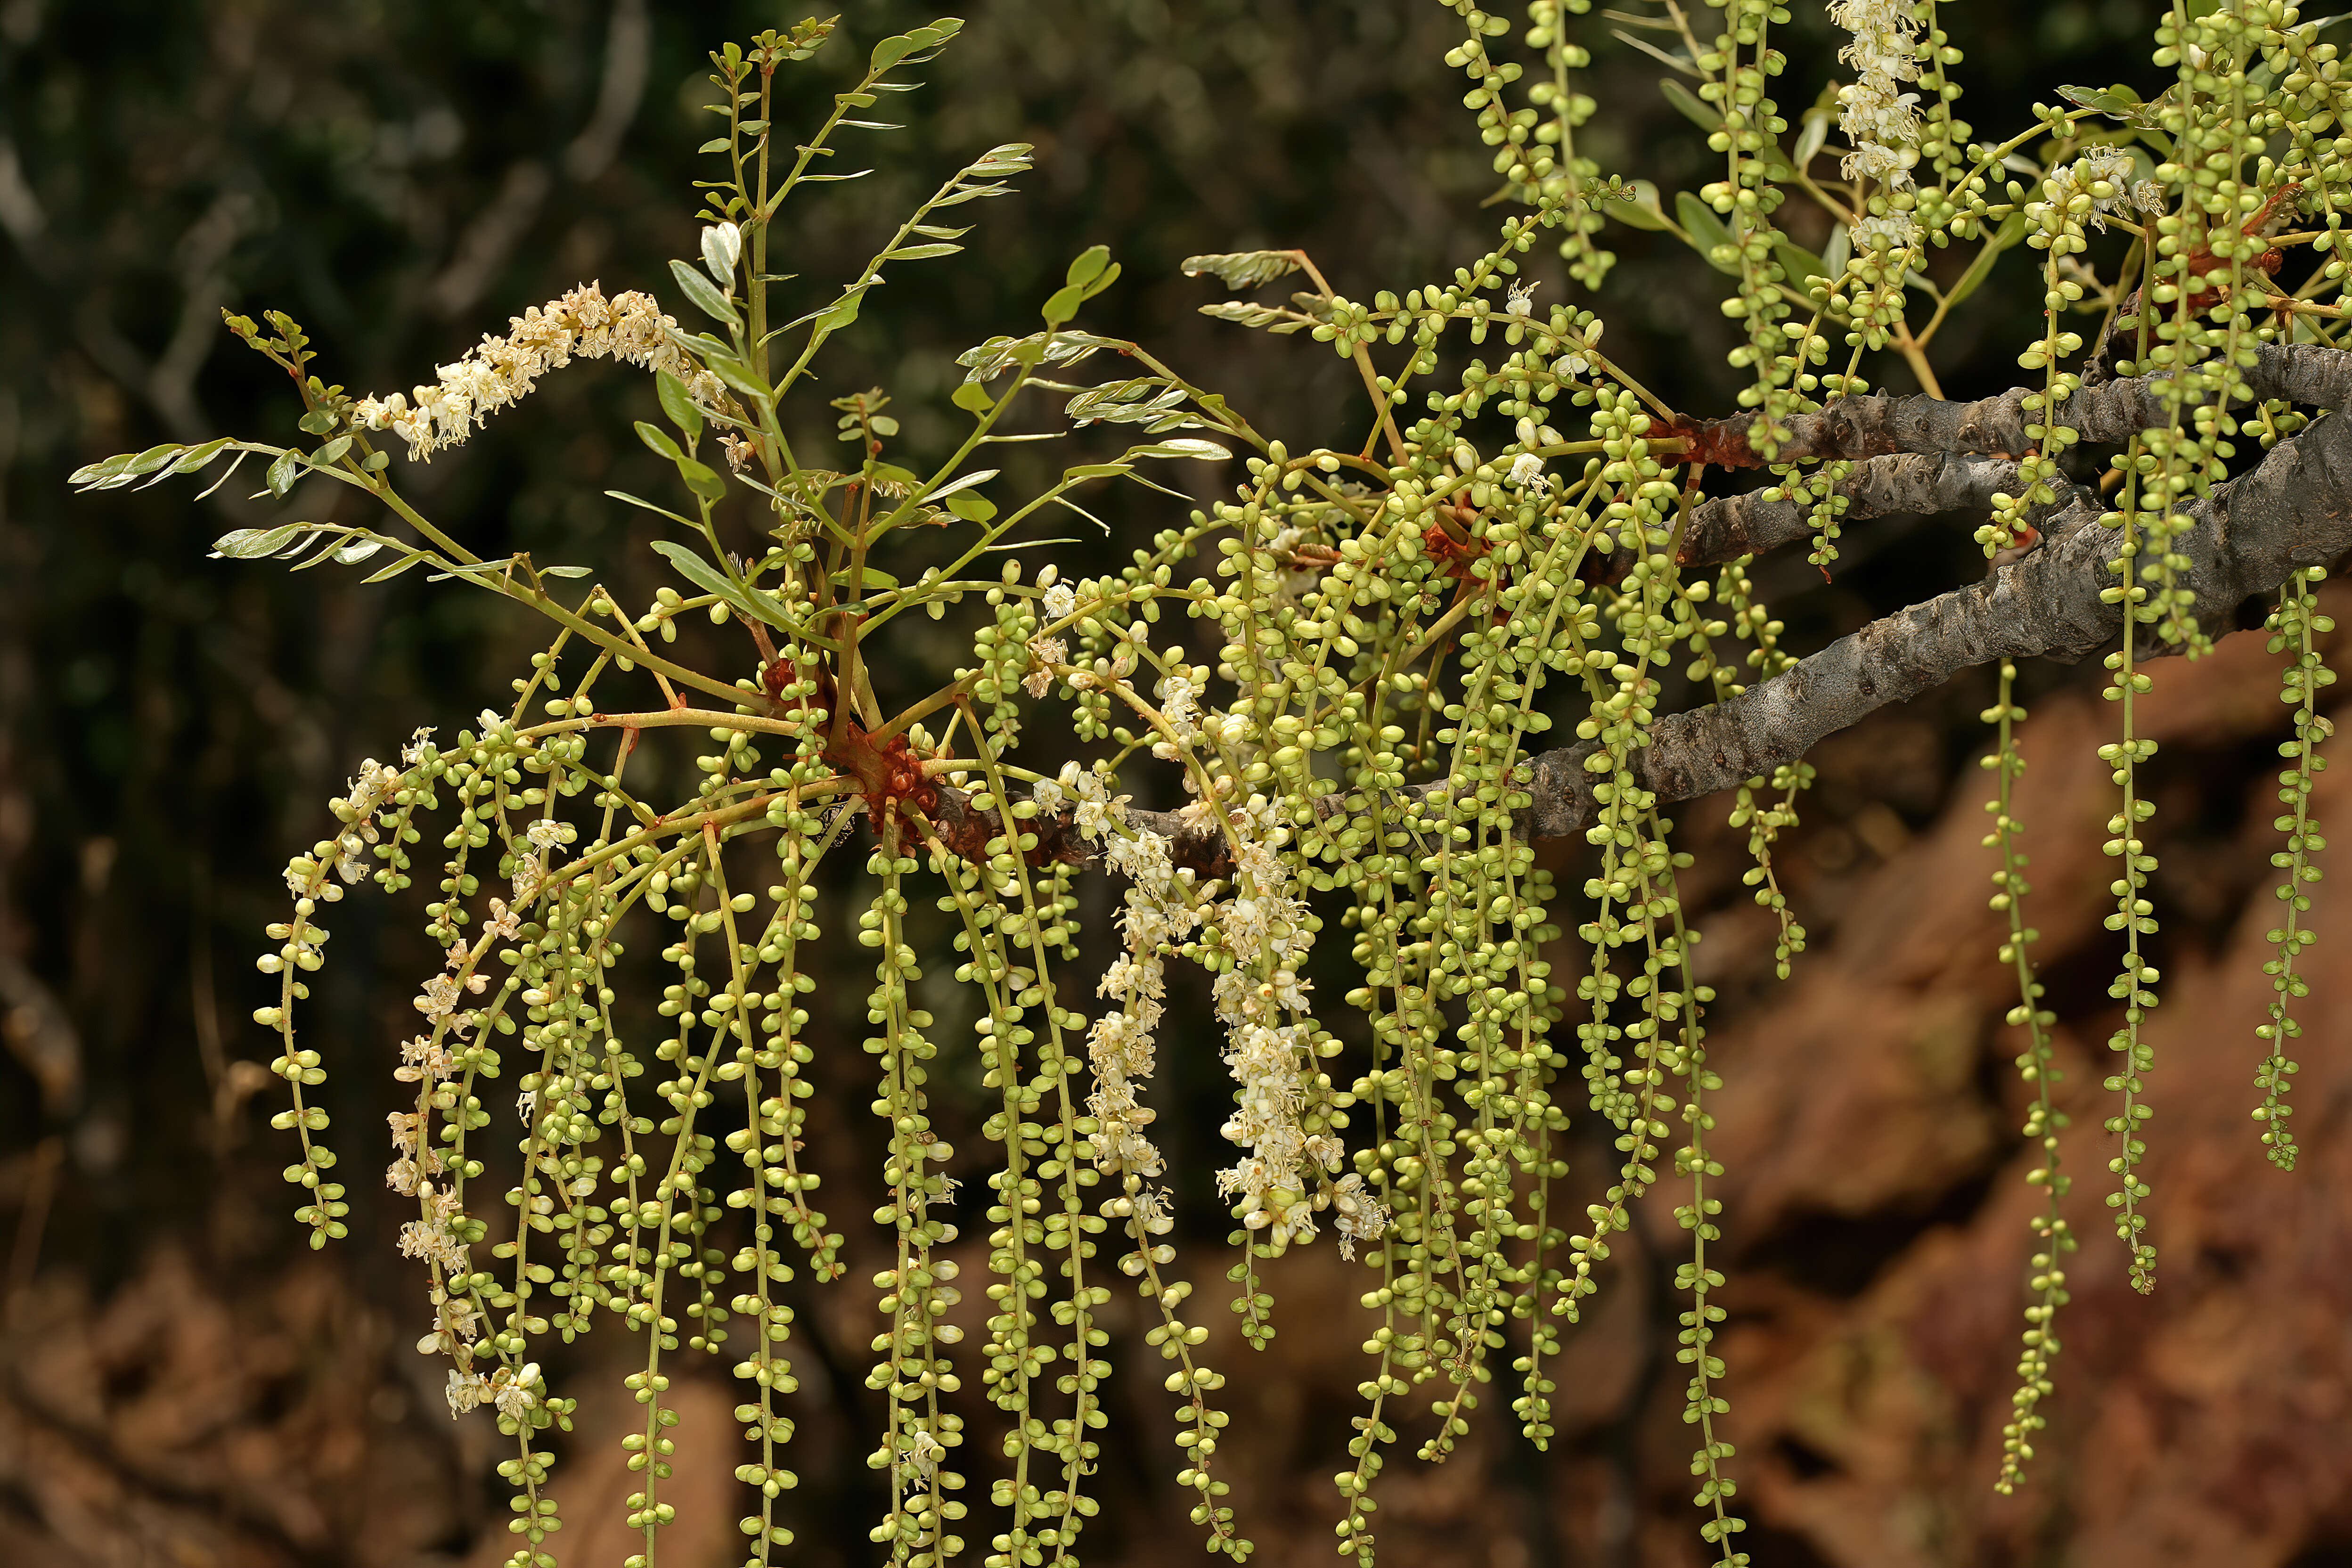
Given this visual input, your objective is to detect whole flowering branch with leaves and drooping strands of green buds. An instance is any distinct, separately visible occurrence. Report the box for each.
[64,0,2352,1568]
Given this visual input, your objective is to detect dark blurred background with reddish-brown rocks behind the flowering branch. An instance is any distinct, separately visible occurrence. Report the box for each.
[0,0,2352,1568]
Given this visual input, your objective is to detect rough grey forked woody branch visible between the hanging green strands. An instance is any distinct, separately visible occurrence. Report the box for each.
[939,345,2352,877]
